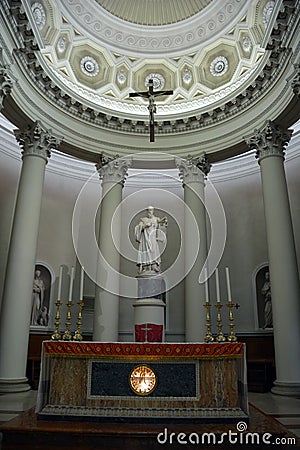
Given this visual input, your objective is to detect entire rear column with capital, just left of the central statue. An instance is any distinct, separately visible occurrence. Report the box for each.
[93,158,128,342]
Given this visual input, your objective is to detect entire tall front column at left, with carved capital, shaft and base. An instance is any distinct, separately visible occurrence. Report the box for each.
[0,122,58,392]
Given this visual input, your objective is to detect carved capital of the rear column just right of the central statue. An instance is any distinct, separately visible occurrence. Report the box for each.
[176,154,211,186]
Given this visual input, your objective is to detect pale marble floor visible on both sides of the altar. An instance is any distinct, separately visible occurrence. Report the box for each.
[0,390,300,450]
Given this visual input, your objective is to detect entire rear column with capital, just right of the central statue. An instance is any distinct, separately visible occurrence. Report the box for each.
[177,155,210,342]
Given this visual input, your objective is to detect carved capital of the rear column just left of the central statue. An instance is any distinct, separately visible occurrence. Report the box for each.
[96,153,130,187]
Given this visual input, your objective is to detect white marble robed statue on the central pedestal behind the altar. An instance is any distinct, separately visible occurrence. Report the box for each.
[134,206,168,274]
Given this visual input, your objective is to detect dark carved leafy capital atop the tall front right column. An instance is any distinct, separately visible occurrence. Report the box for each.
[246,120,293,163]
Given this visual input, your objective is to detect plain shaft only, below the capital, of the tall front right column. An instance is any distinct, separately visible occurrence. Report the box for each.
[260,156,300,392]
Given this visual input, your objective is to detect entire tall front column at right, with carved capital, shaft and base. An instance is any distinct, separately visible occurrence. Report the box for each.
[248,121,300,396]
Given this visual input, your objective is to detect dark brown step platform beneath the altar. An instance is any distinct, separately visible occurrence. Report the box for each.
[0,405,300,450]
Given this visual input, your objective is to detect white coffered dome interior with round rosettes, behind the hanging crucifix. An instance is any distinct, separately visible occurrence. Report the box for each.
[24,0,275,119]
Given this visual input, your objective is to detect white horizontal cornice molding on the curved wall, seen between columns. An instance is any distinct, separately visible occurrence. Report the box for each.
[0,115,300,189]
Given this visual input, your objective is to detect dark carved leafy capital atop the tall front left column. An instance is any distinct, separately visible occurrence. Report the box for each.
[14,121,61,162]
